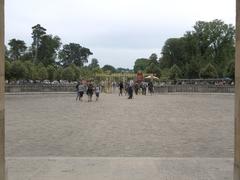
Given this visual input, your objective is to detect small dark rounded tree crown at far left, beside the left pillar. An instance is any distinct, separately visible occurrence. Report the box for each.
[8,39,27,60]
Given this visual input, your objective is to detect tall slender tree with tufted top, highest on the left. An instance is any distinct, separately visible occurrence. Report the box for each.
[32,24,46,63]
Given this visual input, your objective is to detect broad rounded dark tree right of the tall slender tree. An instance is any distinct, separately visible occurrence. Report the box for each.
[59,43,92,67]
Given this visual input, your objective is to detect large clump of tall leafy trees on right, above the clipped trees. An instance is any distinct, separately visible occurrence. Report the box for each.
[160,20,235,78]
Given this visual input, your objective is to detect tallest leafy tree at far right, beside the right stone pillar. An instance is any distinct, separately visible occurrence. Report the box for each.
[189,19,235,76]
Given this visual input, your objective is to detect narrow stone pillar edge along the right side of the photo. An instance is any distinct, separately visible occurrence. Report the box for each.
[234,0,240,180]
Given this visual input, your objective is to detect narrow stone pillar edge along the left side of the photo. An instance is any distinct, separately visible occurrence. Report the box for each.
[0,0,5,180]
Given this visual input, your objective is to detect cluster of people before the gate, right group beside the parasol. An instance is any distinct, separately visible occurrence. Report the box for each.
[118,81,154,99]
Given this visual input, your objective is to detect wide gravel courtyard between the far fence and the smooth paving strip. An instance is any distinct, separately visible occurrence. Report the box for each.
[6,94,234,158]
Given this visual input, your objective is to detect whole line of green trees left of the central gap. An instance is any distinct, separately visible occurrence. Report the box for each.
[5,24,130,81]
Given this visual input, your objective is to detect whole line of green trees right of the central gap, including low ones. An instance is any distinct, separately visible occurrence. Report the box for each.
[134,19,235,79]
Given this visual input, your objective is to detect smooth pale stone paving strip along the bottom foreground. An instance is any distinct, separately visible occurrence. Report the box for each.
[7,157,233,180]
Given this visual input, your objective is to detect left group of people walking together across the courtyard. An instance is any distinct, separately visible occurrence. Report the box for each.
[76,81,101,102]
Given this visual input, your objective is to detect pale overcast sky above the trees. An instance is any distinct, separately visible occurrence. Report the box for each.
[5,0,235,68]
